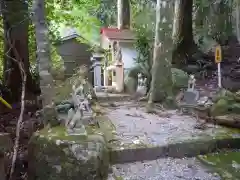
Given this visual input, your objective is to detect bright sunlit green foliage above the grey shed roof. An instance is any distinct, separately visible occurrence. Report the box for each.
[50,0,101,41]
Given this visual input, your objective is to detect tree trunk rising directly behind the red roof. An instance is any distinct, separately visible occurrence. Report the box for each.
[117,0,130,29]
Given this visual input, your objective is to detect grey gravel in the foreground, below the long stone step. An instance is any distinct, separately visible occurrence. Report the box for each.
[108,158,221,180]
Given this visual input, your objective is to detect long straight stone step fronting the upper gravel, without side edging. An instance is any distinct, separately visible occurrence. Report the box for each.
[110,138,240,164]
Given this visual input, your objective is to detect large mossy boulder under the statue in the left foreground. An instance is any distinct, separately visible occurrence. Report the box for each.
[29,126,109,180]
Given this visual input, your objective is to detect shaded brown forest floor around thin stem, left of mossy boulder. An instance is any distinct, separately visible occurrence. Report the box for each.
[0,106,43,180]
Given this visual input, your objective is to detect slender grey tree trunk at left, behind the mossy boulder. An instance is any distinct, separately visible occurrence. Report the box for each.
[33,0,58,126]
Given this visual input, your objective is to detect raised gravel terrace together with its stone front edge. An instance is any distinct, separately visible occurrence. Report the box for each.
[98,104,240,164]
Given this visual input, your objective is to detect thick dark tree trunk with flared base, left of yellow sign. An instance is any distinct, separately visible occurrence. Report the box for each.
[173,0,197,67]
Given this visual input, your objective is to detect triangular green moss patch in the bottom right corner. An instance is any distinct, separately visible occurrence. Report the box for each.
[199,152,240,180]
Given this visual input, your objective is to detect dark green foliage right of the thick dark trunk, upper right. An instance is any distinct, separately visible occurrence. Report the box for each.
[193,0,235,45]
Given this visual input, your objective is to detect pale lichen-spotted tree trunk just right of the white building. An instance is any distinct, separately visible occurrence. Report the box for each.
[149,0,173,104]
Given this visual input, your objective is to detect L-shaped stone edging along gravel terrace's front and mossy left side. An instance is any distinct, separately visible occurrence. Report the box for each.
[98,116,240,164]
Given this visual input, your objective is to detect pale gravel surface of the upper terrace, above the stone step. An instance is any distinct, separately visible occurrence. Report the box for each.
[107,102,232,146]
